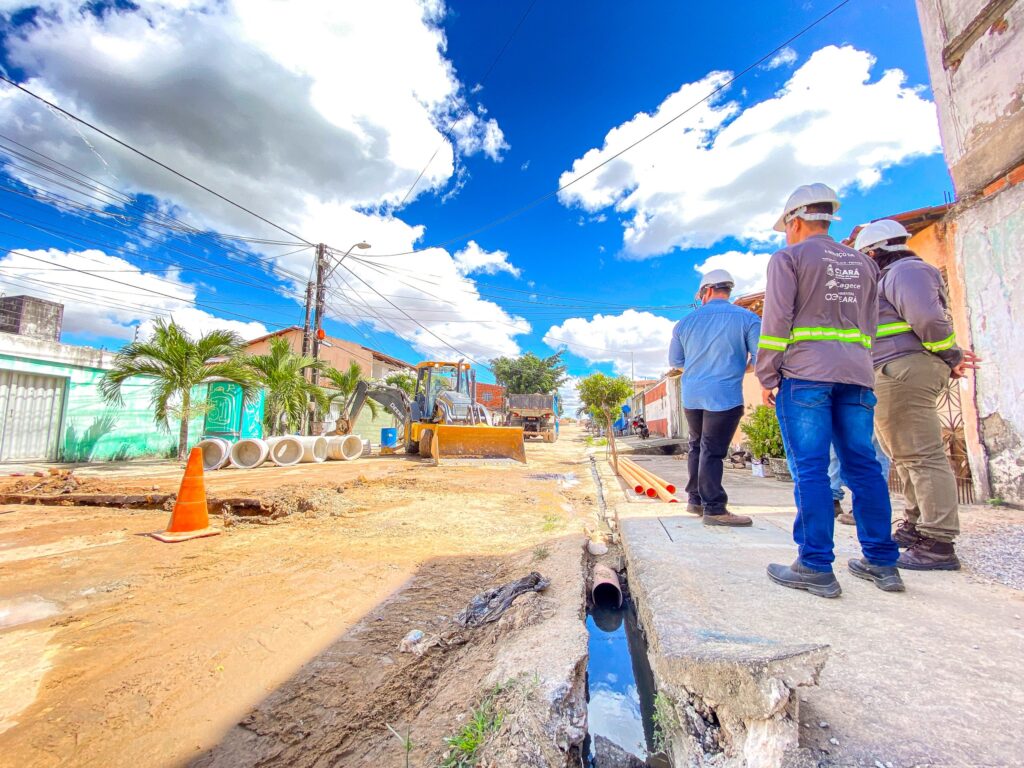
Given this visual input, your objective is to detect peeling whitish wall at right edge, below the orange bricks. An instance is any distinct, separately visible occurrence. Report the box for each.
[952,184,1024,504]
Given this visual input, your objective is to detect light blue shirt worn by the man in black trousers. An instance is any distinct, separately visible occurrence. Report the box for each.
[669,299,761,411]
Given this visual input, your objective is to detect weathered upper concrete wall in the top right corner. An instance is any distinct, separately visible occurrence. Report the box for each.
[918,0,1024,198]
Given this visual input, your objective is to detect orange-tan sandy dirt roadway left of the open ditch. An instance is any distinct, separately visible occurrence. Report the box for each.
[0,428,594,768]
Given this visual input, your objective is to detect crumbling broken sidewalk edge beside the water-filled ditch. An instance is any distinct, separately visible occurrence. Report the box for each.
[622,521,829,768]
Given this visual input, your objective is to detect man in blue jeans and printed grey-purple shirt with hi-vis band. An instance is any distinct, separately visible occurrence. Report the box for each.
[756,183,904,597]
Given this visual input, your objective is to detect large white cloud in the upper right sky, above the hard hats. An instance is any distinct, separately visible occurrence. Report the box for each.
[559,46,940,258]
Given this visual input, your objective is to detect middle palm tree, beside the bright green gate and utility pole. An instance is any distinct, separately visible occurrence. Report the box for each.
[246,336,329,435]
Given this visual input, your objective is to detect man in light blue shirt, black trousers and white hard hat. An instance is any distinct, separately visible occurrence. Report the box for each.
[669,269,761,527]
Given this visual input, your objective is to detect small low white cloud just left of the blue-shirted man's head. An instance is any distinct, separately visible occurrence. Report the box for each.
[544,309,676,379]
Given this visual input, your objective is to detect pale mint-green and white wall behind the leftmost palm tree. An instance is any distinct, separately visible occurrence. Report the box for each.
[0,334,207,462]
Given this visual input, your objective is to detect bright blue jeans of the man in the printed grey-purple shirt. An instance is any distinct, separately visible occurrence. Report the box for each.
[776,379,899,572]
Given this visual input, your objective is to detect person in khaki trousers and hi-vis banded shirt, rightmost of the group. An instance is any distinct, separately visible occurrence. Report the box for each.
[854,219,978,570]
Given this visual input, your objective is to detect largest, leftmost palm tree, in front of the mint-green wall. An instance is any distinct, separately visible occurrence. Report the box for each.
[99,319,257,459]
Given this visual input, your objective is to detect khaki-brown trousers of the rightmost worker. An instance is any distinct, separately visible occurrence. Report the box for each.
[874,352,959,542]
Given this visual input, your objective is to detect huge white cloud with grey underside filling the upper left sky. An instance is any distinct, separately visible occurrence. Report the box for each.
[0,0,529,358]
